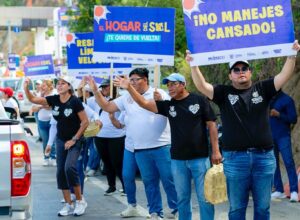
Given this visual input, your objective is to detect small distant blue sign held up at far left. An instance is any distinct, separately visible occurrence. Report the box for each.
[24,54,55,78]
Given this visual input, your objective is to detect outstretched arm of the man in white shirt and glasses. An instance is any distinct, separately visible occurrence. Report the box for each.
[86,76,119,113]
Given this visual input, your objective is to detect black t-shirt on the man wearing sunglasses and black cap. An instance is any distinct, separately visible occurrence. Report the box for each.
[213,78,276,151]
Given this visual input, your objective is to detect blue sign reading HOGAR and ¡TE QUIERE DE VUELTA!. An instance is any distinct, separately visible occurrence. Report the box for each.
[93,6,175,66]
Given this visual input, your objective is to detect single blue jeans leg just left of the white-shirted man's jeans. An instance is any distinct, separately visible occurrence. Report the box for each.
[122,148,137,205]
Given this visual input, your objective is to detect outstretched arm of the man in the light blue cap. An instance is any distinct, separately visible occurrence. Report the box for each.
[114,77,158,113]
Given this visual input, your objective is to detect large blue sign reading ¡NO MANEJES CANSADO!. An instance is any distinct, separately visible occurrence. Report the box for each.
[182,0,295,66]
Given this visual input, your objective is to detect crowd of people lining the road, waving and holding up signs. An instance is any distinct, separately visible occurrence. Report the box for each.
[10,41,300,220]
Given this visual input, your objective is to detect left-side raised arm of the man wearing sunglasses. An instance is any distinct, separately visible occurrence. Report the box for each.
[185,50,214,99]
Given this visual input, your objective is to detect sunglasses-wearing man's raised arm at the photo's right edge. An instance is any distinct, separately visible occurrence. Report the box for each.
[274,40,300,91]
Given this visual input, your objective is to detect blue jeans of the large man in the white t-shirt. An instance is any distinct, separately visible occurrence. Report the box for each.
[135,145,177,217]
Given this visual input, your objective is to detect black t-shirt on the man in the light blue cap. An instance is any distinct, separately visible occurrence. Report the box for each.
[156,94,216,160]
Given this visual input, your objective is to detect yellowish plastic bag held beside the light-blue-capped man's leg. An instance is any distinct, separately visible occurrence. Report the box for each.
[204,163,227,205]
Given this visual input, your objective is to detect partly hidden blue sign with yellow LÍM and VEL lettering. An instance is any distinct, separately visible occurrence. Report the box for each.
[67,33,131,76]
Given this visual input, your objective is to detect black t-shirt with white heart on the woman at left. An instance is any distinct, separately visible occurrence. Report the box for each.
[46,95,84,141]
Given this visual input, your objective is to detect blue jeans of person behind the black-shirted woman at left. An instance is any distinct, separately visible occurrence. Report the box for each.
[38,120,56,159]
